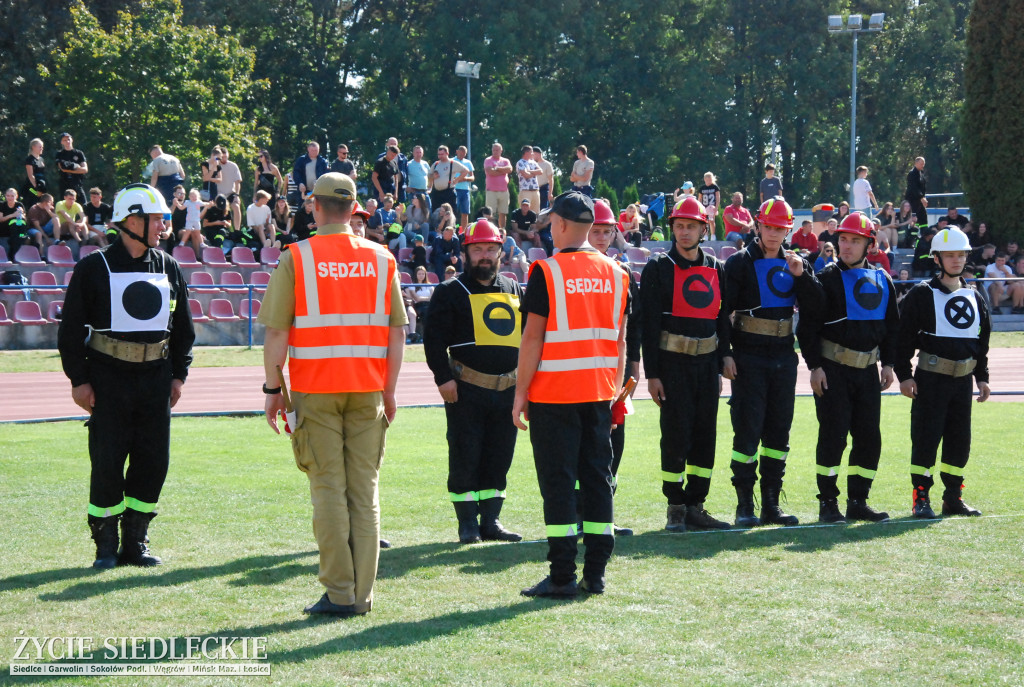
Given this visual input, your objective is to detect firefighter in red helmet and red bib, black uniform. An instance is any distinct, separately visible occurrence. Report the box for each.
[640,196,730,531]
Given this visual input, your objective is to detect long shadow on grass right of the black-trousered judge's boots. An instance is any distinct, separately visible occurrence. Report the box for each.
[615,517,940,560]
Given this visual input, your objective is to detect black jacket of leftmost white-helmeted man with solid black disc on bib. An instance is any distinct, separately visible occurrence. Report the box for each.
[57,239,196,386]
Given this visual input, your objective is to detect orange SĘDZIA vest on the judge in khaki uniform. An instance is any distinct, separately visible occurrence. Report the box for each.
[288,233,396,393]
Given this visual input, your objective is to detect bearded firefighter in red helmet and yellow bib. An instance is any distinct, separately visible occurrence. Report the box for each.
[423,219,522,544]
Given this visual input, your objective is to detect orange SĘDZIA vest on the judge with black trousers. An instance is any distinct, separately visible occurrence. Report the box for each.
[529,250,630,403]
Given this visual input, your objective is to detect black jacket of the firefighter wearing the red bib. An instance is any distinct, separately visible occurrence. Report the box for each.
[640,243,731,379]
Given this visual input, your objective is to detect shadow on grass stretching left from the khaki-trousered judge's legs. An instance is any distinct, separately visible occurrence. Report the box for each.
[36,551,316,601]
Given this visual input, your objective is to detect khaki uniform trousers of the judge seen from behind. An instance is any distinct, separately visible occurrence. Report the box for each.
[292,391,388,612]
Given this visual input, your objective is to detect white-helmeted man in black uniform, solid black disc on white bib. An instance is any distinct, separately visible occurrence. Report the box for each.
[57,183,196,568]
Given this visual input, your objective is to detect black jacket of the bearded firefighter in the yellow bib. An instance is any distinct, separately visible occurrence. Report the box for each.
[423,270,522,386]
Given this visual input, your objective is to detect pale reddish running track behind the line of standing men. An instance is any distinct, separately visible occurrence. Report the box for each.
[6,348,1024,422]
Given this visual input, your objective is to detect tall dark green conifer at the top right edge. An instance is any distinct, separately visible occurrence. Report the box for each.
[961,0,1024,239]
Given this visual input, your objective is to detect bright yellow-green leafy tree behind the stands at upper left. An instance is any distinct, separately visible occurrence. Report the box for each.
[41,0,265,187]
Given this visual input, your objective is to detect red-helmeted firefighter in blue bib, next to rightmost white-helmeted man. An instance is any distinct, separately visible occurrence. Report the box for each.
[797,212,899,523]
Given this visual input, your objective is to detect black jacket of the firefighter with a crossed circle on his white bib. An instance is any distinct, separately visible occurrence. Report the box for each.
[893,276,992,382]
